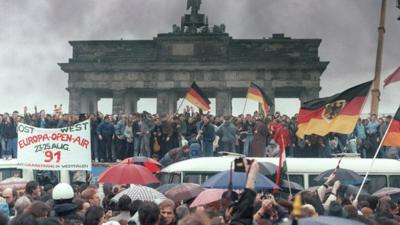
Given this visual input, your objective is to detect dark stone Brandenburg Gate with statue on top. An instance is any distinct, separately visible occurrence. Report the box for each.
[59,0,328,115]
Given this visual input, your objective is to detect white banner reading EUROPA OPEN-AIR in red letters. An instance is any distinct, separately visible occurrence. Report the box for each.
[17,120,92,170]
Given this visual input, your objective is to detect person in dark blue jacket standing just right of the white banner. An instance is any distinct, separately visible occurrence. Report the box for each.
[97,115,114,162]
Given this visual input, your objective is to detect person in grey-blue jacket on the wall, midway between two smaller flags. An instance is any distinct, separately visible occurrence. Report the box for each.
[217,116,236,152]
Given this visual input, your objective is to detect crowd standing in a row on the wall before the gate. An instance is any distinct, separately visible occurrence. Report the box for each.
[0,107,400,162]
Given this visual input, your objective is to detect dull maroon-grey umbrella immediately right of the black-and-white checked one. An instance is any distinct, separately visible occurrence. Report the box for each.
[165,183,204,202]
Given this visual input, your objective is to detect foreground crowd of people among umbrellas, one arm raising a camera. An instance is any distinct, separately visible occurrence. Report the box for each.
[0,161,400,225]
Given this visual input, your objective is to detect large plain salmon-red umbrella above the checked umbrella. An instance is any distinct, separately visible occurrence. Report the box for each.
[99,163,160,185]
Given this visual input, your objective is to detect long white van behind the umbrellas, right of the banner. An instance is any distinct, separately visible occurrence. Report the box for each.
[159,156,400,193]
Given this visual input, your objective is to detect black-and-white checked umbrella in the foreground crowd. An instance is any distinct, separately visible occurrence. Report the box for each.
[111,185,166,202]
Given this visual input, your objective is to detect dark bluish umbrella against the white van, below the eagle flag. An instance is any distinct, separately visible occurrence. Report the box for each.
[314,168,363,185]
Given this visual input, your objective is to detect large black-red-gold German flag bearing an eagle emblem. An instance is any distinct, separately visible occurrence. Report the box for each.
[297,81,372,138]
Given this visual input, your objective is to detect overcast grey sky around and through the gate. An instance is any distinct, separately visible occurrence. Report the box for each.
[0,0,400,115]
